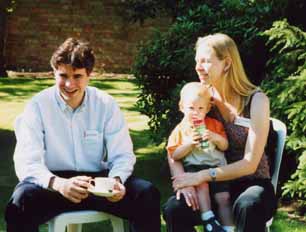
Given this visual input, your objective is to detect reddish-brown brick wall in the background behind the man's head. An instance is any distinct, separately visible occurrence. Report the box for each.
[4,0,170,73]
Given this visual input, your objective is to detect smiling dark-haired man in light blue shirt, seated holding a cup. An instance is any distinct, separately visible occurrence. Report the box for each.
[5,38,160,232]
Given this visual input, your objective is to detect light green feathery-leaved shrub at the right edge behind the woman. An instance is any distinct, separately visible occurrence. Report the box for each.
[262,20,306,200]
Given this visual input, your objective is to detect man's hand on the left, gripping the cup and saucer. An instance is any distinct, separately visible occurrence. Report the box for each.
[52,176,91,203]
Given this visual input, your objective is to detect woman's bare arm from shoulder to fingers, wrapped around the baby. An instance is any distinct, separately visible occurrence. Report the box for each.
[173,93,270,189]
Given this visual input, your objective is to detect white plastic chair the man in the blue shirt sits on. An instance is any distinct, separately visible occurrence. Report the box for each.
[48,210,124,232]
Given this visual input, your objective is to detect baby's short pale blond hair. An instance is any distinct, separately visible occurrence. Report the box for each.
[179,82,211,110]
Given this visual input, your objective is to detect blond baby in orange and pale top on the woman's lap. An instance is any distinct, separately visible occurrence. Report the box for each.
[167,82,234,232]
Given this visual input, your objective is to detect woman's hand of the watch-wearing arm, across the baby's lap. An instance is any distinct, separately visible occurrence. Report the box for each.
[172,172,203,191]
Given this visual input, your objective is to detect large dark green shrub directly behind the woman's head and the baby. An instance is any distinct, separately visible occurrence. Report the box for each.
[133,0,284,142]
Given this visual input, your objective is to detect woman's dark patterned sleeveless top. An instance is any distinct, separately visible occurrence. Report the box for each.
[209,91,270,179]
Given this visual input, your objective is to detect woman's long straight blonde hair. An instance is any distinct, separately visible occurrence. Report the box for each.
[195,33,257,113]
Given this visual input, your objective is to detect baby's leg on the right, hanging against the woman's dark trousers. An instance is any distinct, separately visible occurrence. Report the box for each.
[215,192,234,226]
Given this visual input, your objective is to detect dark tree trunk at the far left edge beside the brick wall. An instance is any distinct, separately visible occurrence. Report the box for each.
[0,1,7,77]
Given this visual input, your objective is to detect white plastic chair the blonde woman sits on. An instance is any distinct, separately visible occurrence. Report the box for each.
[266,118,287,232]
